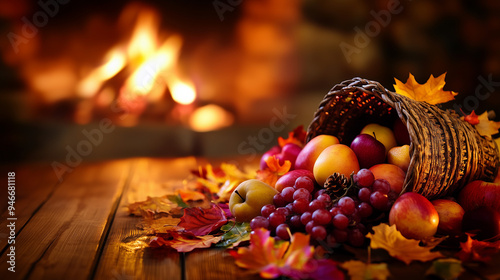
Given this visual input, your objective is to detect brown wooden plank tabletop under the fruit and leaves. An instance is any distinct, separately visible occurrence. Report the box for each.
[0,157,500,280]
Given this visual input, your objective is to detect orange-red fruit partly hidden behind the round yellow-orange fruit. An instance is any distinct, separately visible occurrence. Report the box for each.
[295,134,340,172]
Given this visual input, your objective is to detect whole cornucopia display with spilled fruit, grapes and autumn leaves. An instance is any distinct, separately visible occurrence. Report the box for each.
[129,74,500,279]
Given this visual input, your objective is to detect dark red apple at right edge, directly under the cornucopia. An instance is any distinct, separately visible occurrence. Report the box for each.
[458,180,500,212]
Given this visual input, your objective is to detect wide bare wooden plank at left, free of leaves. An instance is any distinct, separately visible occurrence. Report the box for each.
[0,160,130,279]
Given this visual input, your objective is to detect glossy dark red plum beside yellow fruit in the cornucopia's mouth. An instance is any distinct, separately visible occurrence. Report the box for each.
[351,134,386,168]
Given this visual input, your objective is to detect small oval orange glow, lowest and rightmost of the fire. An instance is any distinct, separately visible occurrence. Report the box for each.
[189,104,234,132]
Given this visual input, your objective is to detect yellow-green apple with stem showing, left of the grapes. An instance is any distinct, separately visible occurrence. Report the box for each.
[229,179,278,222]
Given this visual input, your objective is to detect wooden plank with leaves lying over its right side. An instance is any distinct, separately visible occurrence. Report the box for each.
[94,157,197,280]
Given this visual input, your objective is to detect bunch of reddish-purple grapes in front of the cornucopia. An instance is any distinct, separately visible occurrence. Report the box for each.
[250,169,397,247]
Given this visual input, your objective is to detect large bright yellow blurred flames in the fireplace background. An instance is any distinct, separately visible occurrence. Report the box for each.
[77,5,186,104]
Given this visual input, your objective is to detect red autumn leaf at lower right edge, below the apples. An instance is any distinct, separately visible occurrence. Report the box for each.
[457,233,500,263]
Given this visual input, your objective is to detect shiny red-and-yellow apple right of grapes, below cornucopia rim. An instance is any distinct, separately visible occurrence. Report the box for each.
[389,192,439,240]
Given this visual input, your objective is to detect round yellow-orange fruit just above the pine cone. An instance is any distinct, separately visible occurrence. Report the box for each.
[313,144,359,186]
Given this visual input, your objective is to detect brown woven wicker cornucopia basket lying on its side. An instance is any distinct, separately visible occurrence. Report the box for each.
[307,78,500,199]
